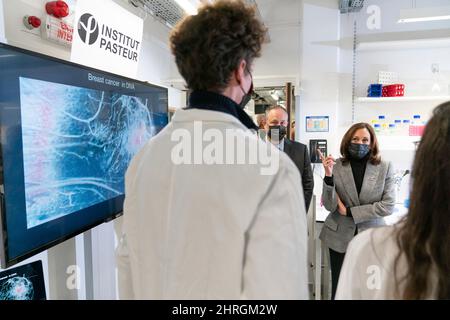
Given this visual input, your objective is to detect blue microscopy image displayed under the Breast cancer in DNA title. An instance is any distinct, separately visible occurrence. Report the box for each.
[20,77,155,228]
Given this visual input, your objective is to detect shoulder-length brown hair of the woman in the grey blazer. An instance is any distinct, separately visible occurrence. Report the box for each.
[340,122,381,165]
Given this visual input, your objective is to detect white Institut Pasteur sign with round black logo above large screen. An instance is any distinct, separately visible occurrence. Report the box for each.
[70,0,143,78]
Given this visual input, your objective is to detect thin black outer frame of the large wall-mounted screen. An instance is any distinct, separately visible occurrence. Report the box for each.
[0,42,169,269]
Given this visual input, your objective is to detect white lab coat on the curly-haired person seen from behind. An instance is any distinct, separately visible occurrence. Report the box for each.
[117,109,308,299]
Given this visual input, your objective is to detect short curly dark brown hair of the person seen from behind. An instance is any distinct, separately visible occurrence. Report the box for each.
[170,0,267,92]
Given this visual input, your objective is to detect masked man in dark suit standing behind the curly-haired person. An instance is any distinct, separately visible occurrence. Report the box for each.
[265,106,314,211]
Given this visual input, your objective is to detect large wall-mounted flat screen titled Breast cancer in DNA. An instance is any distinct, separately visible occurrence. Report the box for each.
[0,44,168,267]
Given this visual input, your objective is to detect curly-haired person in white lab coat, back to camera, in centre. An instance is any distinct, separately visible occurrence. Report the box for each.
[117,0,308,299]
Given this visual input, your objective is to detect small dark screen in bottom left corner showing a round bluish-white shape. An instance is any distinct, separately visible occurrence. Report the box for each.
[0,260,47,300]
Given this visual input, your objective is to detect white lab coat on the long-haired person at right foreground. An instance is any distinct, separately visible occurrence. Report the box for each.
[335,224,437,300]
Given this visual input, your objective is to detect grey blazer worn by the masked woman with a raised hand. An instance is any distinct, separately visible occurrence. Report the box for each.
[319,159,395,253]
